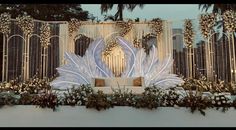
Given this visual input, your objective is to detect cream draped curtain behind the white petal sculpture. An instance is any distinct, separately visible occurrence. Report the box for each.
[60,21,173,76]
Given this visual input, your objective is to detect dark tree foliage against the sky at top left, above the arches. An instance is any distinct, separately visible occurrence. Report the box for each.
[0,4,88,21]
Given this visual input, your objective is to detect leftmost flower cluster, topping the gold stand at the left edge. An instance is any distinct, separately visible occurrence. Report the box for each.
[0,13,11,35]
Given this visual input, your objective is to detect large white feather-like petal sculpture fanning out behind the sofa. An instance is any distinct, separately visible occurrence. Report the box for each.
[50,37,184,89]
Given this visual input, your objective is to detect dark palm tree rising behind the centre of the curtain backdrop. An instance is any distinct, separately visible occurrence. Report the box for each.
[101,4,144,21]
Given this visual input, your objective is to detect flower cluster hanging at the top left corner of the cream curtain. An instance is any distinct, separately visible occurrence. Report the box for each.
[68,18,82,37]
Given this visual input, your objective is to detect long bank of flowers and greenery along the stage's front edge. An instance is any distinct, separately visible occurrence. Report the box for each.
[0,76,236,115]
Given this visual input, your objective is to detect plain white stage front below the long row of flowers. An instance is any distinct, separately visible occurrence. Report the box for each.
[0,105,236,127]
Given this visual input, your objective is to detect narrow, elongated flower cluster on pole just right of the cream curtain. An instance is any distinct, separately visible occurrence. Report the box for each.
[184,19,194,48]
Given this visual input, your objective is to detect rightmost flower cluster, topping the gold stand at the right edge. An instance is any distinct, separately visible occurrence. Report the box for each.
[223,10,236,33]
